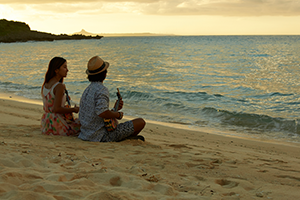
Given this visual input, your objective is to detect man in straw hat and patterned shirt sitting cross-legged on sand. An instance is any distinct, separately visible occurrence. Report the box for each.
[78,56,146,142]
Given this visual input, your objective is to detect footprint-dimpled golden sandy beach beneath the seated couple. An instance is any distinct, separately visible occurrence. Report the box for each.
[0,95,300,200]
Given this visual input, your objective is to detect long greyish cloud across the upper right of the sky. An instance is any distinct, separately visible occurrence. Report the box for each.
[143,0,300,16]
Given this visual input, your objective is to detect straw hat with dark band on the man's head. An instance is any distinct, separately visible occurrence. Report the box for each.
[86,56,109,75]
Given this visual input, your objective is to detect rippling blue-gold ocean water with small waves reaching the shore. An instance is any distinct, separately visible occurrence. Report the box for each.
[0,36,300,143]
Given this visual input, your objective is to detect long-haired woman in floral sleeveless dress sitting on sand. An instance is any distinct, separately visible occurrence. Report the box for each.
[41,57,80,136]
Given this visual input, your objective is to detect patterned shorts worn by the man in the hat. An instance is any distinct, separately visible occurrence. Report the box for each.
[100,121,134,142]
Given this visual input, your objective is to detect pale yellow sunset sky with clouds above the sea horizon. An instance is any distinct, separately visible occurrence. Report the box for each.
[0,0,300,35]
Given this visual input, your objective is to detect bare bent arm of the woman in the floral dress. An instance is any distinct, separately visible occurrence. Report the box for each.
[52,83,79,114]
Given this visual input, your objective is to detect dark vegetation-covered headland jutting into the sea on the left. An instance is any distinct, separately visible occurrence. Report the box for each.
[0,19,103,43]
